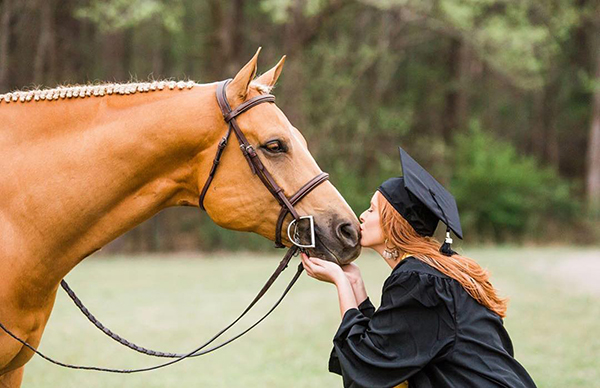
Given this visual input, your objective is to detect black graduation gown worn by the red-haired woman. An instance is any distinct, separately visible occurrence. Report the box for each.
[329,257,535,388]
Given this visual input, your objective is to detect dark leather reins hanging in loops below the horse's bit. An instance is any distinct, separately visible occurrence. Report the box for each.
[0,247,304,373]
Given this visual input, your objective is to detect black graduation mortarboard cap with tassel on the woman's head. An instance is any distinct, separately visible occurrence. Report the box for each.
[379,147,462,255]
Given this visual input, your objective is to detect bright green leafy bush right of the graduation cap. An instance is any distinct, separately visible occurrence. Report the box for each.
[451,122,579,241]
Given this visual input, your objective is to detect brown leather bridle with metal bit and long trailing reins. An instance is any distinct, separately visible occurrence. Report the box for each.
[0,79,329,373]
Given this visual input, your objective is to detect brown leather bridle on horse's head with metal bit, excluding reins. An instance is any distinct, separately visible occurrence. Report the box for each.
[199,79,329,248]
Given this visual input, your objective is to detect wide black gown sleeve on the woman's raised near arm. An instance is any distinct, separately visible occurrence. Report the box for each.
[330,272,456,388]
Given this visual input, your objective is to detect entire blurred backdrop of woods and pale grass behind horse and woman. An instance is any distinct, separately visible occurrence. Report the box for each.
[0,0,600,388]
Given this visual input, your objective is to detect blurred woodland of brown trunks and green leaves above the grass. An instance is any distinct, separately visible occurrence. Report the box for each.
[0,0,600,253]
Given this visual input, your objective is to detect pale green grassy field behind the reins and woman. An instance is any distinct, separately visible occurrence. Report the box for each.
[23,248,600,388]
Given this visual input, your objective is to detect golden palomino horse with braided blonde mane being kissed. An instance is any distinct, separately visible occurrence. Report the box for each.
[0,50,360,388]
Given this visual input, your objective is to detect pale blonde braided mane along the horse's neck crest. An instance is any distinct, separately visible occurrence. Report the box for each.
[0,81,198,104]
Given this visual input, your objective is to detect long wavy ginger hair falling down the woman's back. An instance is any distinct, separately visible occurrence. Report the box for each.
[377,194,507,318]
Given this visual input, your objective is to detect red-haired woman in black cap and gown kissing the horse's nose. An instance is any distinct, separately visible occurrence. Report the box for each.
[302,149,535,388]
